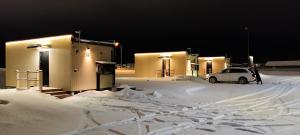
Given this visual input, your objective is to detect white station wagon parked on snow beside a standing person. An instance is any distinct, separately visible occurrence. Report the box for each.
[208,67,256,84]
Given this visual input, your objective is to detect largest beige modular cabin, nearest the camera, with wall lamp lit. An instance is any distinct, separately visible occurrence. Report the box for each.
[6,35,115,91]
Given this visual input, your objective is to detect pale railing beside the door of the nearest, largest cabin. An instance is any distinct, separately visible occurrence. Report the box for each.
[16,70,43,90]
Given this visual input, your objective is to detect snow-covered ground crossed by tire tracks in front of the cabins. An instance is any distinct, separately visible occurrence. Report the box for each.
[0,75,300,135]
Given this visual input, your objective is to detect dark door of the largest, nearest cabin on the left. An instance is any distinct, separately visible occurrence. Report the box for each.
[40,51,49,86]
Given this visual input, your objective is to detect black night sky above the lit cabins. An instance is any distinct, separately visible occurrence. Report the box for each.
[0,0,300,67]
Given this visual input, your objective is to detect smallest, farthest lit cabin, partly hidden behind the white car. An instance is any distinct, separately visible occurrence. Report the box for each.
[198,56,230,77]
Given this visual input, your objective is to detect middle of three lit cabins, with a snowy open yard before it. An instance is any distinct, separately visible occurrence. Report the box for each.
[134,51,198,78]
